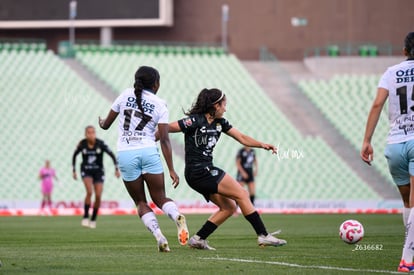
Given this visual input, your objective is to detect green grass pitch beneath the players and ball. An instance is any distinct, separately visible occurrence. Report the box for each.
[0,214,404,274]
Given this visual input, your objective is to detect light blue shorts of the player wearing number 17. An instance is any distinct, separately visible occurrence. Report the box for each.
[118,147,164,181]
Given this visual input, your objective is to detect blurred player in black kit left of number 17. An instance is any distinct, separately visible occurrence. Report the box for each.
[72,125,120,228]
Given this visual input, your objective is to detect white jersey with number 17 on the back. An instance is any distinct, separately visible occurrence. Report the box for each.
[111,88,169,151]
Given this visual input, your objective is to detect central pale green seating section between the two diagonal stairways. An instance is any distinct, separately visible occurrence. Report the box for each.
[76,45,379,200]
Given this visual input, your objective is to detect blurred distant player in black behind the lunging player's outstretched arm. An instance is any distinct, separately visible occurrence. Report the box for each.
[236,146,258,205]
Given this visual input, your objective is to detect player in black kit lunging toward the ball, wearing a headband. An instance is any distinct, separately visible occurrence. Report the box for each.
[169,89,286,250]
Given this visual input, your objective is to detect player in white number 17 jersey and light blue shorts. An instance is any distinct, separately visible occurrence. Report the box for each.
[99,66,189,252]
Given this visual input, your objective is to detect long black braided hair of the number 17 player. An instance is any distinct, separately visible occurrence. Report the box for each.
[134,66,160,119]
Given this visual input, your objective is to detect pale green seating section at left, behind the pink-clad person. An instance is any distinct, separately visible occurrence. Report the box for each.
[0,50,199,209]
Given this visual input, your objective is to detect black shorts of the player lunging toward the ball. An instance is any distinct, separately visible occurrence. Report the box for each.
[184,165,226,201]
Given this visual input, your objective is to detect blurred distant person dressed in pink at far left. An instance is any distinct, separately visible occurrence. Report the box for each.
[39,160,58,215]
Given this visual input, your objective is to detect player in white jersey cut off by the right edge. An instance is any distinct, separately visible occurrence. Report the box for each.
[361,32,414,272]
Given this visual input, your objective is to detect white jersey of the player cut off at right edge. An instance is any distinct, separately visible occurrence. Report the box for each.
[384,61,414,144]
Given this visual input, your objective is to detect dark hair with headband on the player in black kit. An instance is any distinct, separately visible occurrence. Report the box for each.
[185,88,225,117]
